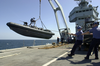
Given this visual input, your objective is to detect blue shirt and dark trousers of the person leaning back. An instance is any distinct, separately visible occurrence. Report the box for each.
[71,30,84,55]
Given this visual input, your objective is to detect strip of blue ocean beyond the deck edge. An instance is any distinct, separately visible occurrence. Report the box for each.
[0,40,56,50]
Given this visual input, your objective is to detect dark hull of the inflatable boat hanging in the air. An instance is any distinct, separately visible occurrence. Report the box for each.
[7,22,54,39]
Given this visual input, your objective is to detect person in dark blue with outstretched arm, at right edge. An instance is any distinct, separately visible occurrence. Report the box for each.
[83,22,100,59]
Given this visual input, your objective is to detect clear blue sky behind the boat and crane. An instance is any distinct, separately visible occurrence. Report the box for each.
[0,0,100,40]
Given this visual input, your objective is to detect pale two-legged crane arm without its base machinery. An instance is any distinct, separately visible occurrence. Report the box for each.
[48,0,70,37]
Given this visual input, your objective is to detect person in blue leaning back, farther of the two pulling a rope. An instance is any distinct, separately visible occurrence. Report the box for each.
[68,26,84,56]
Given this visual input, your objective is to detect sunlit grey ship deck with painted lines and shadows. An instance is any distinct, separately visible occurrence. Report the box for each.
[0,44,100,66]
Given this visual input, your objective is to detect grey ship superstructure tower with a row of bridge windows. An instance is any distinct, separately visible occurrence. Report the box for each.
[69,0,100,42]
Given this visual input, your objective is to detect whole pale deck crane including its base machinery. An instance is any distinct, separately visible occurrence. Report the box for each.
[48,0,71,41]
